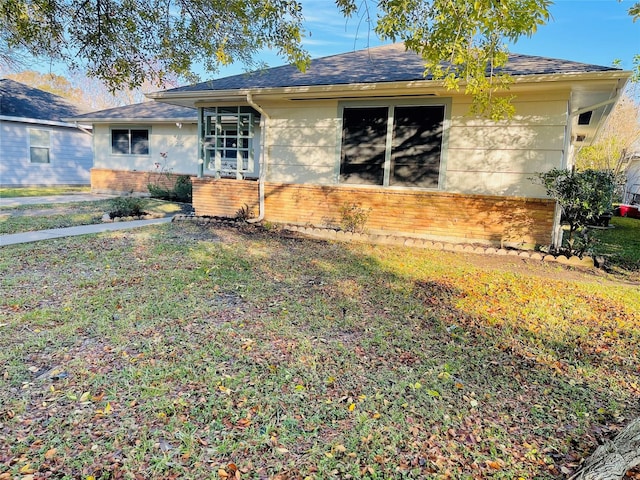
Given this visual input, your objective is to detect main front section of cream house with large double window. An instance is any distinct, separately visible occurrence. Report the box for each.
[148,44,630,247]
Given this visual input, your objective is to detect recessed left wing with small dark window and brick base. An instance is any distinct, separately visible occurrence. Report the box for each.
[67,102,198,193]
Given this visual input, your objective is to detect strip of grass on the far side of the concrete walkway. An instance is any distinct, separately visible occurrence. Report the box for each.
[0,199,189,235]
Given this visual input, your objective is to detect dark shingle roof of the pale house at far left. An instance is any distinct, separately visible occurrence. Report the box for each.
[0,78,83,122]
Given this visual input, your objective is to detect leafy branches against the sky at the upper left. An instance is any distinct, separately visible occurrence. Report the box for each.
[0,0,308,91]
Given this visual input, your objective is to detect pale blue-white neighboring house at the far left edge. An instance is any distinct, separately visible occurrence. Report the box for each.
[0,79,93,186]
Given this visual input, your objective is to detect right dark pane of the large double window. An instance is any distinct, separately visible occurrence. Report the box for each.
[389,105,444,188]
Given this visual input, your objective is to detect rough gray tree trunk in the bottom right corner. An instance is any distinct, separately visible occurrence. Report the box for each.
[570,418,640,480]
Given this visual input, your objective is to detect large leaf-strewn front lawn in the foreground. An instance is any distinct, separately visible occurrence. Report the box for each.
[0,222,640,480]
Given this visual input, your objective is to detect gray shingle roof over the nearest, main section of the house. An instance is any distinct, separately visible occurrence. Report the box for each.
[166,43,618,93]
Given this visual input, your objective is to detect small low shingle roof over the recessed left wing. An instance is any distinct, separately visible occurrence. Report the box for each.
[73,102,198,123]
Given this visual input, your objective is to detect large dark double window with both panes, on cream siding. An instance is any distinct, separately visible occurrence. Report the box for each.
[340,105,445,188]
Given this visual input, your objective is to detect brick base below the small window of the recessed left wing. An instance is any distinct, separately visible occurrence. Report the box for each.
[91,168,179,195]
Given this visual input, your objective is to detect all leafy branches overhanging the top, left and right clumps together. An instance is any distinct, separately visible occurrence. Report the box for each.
[0,0,640,118]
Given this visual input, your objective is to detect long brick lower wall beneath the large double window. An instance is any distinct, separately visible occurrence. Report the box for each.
[192,177,555,246]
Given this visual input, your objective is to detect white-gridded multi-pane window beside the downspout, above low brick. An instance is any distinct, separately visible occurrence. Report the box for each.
[203,107,259,178]
